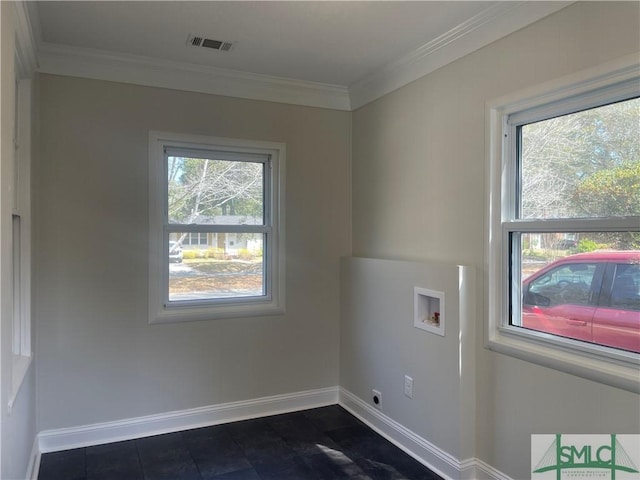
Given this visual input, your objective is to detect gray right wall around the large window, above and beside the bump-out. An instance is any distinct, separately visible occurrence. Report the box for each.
[350,2,640,479]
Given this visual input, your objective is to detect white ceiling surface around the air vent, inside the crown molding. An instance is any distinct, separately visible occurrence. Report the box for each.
[38,1,495,86]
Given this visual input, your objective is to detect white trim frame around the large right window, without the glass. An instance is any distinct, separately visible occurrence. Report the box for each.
[485,54,640,393]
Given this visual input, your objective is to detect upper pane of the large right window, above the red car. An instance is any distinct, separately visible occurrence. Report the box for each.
[519,98,640,219]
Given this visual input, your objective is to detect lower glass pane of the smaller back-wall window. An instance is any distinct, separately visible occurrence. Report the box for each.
[168,232,266,302]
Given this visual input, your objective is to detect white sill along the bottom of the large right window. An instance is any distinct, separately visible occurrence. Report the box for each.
[486,328,640,393]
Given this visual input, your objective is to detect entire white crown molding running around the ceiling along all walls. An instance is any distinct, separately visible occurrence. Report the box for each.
[30,1,574,111]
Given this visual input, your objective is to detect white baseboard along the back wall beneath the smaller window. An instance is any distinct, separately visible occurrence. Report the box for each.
[37,387,338,454]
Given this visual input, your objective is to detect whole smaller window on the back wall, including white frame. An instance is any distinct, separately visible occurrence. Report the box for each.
[149,132,285,323]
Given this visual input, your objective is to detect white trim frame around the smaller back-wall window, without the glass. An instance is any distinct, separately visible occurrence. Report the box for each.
[149,131,286,324]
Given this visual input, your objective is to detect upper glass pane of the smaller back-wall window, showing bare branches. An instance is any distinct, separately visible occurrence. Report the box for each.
[167,156,264,226]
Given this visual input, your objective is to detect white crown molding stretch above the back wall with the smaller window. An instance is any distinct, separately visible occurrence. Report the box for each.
[39,42,350,110]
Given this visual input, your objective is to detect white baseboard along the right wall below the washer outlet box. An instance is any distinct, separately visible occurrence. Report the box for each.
[338,388,511,480]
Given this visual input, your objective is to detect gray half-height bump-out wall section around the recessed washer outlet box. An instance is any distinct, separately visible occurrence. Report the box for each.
[340,258,476,466]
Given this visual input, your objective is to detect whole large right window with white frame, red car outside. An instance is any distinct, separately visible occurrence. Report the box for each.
[487,60,640,391]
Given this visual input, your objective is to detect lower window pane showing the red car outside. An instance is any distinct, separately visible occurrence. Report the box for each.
[511,232,640,352]
